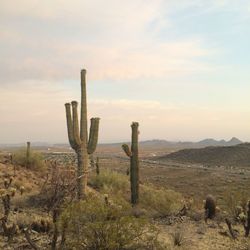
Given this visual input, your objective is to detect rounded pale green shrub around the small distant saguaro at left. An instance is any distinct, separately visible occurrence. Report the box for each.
[13,149,45,170]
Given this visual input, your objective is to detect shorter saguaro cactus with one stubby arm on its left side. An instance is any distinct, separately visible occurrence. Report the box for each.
[122,122,139,205]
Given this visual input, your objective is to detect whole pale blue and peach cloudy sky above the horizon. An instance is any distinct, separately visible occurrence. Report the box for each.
[0,0,250,144]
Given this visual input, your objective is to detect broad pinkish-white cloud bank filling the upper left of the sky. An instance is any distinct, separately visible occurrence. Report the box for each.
[0,0,214,83]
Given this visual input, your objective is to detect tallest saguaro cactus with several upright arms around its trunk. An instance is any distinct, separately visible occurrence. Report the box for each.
[65,69,100,199]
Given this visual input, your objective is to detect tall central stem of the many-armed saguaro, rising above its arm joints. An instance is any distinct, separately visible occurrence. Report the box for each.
[80,69,88,146]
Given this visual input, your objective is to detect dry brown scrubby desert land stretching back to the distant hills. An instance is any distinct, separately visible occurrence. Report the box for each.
[0,140,250,249]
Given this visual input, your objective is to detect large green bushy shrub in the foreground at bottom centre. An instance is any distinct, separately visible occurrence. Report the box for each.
[59,195,163,250]
